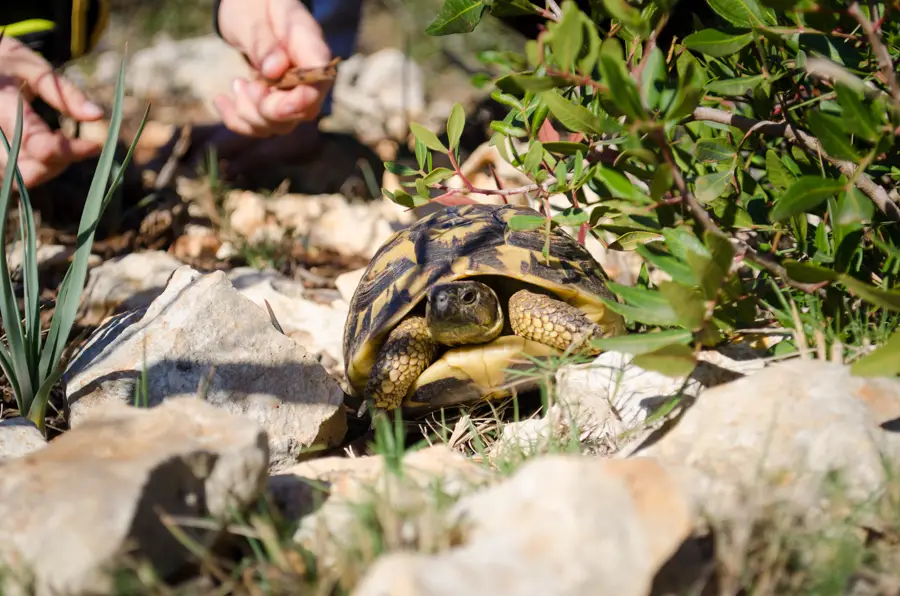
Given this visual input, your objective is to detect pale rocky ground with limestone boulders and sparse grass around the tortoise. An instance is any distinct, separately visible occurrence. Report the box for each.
[0,8,900,596]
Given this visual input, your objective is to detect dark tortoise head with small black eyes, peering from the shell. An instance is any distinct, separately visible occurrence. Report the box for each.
[425,280,503,346]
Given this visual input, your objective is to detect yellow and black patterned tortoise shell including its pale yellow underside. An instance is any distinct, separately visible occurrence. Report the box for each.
[343,205,624,407]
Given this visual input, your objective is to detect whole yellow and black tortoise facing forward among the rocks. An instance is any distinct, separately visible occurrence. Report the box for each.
[343,204,624,415]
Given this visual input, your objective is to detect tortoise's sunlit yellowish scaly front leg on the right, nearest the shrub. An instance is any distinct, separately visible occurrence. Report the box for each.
[509,290,604,354]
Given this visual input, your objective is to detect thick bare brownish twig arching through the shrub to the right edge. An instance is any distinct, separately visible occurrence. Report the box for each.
[692,107,900,221]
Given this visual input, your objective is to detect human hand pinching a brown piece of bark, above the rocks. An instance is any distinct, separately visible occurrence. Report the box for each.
[214,0,331,137]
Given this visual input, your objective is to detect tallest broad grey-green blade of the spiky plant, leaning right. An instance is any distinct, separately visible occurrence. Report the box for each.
[40,59,137,376]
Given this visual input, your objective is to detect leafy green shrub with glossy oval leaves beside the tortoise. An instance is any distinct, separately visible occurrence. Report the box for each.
[386,0,900,375]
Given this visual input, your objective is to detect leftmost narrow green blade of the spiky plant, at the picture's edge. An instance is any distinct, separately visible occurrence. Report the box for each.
[0,95,34,408]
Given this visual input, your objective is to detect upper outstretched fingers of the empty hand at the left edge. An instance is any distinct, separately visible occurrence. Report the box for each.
[0,37,103,122]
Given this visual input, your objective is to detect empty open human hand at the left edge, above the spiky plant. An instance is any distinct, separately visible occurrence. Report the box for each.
[0,36,103,187]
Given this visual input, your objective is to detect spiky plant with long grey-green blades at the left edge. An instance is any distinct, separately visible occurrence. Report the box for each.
[0,60,149,432]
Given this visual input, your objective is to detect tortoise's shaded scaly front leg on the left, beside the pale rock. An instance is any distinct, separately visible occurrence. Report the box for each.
[365,317,437,411]
